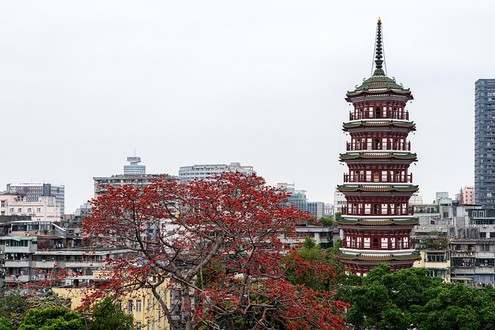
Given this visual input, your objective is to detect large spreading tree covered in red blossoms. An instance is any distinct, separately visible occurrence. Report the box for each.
[83,173,343,329]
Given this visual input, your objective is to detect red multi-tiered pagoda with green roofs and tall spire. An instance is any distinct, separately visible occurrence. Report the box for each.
[337,19,419,276]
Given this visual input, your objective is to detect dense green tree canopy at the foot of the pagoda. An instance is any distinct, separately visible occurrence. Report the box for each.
[346,265,495,330]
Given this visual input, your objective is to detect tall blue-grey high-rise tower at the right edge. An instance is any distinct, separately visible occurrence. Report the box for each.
[474,79,495,208]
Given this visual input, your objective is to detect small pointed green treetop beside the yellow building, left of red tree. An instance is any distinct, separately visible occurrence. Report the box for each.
[84,297,134,330]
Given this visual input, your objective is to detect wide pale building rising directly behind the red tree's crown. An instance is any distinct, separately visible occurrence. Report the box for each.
[179,162,256,183]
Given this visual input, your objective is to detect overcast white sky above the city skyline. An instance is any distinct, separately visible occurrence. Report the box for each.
[0,0,495,212]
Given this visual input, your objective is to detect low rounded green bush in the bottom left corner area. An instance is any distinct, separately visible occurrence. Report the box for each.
[19,307,84,330]
